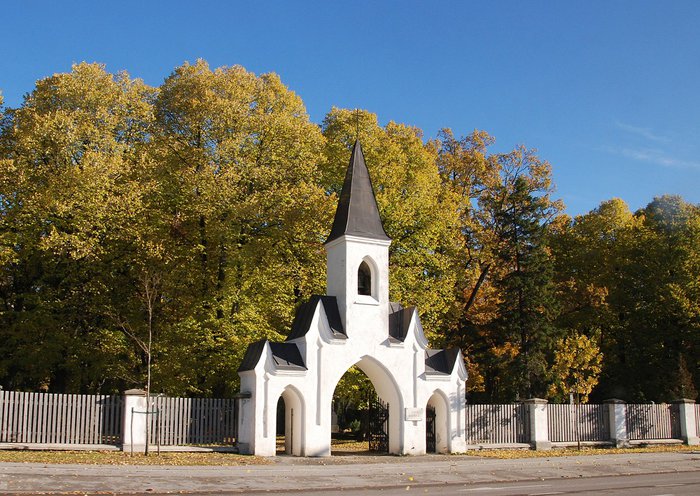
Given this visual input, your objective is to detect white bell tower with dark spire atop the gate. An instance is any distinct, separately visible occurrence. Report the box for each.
[325,141,391,340]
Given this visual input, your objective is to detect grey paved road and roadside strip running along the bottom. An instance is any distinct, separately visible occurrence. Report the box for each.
[0,452,700,496]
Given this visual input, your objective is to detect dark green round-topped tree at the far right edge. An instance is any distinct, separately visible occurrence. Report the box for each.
[611,196,700,401]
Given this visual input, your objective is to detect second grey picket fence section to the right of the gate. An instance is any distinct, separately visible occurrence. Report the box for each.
[547,404,610,442]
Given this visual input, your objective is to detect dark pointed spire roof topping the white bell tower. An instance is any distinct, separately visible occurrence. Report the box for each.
[326,141,390,243]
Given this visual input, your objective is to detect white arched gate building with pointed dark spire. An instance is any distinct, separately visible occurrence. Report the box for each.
[238,142,467,456]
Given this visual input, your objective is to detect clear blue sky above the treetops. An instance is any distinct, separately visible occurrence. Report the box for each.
[0,0,700,215]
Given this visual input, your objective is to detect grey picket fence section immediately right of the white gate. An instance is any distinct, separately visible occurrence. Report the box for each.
[466,403,530,444]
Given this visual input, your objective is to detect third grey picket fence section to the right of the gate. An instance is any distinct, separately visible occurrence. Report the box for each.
[625,404,681,440]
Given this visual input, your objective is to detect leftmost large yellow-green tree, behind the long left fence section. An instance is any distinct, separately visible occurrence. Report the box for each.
[0,64,151,391]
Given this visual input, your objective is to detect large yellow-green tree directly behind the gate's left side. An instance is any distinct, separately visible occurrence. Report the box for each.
[143,61,332,394]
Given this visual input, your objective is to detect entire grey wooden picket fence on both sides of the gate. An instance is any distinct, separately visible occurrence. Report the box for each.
[0,390,700,452]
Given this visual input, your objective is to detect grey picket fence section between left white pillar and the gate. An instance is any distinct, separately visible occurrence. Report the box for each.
[149,396,237,446]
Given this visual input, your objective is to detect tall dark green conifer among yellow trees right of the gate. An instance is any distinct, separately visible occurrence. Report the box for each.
[486,165,557,397]
